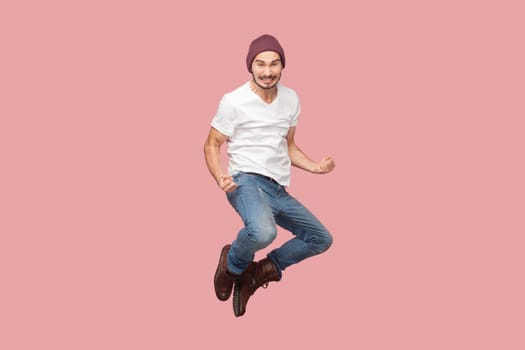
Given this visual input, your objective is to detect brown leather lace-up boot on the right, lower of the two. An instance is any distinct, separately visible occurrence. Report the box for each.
[233,258,281,317]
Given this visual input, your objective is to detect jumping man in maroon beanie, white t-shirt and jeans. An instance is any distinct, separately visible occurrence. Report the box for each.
[204,34,335,316]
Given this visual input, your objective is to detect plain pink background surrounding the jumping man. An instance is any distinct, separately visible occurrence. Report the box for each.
[0,0,525,350]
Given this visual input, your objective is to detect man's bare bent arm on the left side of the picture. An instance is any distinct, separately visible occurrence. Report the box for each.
[204,128,237,192]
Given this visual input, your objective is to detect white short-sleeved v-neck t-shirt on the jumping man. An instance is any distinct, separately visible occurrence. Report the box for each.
[211,82,301,186]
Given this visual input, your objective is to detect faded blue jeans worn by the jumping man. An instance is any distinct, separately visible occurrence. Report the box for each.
[226,173,332,275]
